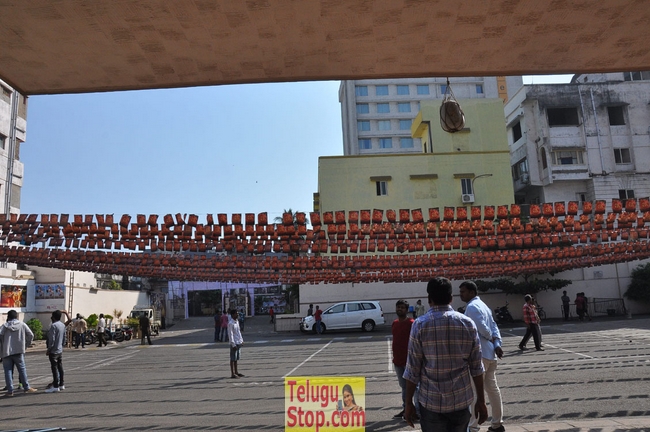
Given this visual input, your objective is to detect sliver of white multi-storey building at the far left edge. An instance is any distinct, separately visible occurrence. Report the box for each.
[0,80,27,214]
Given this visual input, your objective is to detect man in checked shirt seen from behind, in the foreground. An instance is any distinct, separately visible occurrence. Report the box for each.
[404,277,487,432]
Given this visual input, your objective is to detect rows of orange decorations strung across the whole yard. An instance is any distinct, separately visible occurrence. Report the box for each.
[0,198,650,284]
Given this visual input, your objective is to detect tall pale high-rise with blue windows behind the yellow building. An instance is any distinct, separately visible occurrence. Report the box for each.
[339,76,523,156]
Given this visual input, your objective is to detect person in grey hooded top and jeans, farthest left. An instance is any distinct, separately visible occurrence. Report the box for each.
[0,309,36,397]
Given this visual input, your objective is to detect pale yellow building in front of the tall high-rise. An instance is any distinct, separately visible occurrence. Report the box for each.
[317,99,514,213]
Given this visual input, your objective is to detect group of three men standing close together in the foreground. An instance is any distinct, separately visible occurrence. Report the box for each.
[392,277,505,432]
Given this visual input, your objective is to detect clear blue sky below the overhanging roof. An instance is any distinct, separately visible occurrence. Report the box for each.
[20,75,571,220]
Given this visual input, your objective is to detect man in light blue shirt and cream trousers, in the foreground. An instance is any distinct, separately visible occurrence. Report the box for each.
[460,281,505,432]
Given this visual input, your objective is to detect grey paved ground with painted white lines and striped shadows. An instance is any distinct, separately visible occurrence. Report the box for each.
[0,317,650,432]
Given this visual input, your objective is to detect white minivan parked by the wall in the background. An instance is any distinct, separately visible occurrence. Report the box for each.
[300,300,385,332]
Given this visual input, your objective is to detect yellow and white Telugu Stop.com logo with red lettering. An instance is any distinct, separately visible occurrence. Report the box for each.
[284,377,366,432]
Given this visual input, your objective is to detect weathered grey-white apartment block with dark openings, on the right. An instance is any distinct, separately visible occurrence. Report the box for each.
[505,72,650,205]
